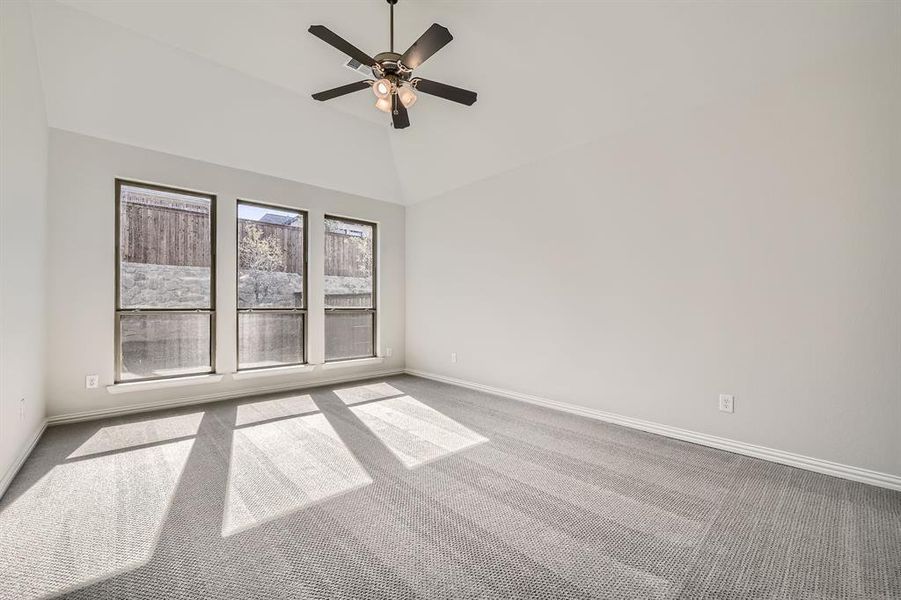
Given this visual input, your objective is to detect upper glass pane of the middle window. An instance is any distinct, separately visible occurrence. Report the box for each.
[238,202,304,308]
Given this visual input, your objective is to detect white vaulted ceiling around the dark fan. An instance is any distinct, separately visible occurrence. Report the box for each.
[32,0,897,203]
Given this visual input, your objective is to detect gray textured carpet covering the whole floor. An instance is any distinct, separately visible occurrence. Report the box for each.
[0,376,901,600]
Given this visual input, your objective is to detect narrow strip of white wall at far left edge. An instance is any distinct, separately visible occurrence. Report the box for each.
[0,1,47,482]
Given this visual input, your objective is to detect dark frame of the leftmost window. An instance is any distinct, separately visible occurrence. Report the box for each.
[113,177,218,384]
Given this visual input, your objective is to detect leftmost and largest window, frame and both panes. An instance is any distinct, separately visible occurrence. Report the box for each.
[115,179,216,382]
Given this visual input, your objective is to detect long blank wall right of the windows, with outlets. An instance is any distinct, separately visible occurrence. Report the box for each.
[407,36,901,475]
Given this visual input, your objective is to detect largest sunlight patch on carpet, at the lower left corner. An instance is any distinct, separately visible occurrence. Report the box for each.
[0,438,194,600]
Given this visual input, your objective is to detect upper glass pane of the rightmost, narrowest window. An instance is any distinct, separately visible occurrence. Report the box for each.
[325,217,375,308]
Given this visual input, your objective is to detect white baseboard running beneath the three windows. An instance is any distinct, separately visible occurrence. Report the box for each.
[47,369,404,425]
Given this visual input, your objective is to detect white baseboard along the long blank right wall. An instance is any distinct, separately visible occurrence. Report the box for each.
[406,369,901,491]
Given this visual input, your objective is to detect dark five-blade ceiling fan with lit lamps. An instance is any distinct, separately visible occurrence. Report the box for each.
[309,0,476,129]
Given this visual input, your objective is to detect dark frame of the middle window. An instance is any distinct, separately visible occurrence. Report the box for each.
[235,198,310,373]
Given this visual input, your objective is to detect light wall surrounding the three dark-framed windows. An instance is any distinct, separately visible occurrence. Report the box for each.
[46,129,404,417]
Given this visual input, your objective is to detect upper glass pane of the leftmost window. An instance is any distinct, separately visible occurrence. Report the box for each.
[119,183,212,308]
